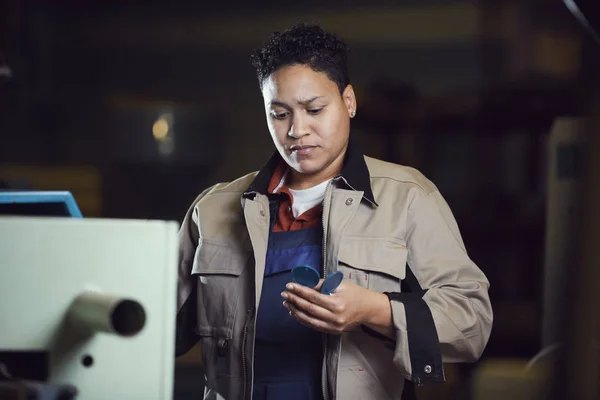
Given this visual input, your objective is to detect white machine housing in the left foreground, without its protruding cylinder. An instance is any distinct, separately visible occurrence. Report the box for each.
[0,217,178,400]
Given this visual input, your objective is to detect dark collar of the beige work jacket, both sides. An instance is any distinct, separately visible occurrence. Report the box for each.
[244,140,377,205]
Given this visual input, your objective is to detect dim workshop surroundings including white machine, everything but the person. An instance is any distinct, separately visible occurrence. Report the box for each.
[0,0,600,400]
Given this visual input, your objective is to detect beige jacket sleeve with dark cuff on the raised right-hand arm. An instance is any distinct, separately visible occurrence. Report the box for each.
[388,189,493,385]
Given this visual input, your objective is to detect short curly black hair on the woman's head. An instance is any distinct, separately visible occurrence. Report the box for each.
[251,22,350,93]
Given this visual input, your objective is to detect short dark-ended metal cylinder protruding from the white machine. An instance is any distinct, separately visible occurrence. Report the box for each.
[68,290,146,336]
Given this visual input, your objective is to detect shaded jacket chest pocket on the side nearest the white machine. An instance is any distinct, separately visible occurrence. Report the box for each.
[192,240,251,339]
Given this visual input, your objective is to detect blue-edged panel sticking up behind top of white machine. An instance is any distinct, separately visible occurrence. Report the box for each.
[0,191,83,218]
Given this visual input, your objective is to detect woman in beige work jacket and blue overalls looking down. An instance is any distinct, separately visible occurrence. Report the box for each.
[177,24,492,400]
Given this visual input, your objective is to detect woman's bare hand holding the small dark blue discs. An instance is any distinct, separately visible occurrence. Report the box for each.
[281,280,393,337]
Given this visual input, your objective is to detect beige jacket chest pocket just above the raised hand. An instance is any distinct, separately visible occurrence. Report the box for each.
[338,237,408,293]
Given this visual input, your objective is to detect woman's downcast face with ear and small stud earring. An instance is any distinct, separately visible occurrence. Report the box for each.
[262,65,356,188]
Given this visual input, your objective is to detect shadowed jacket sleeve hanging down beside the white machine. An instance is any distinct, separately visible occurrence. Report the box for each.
[175,189,210,357]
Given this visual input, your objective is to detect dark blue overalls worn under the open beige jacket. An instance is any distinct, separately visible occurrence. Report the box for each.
[253,202,324,400]
